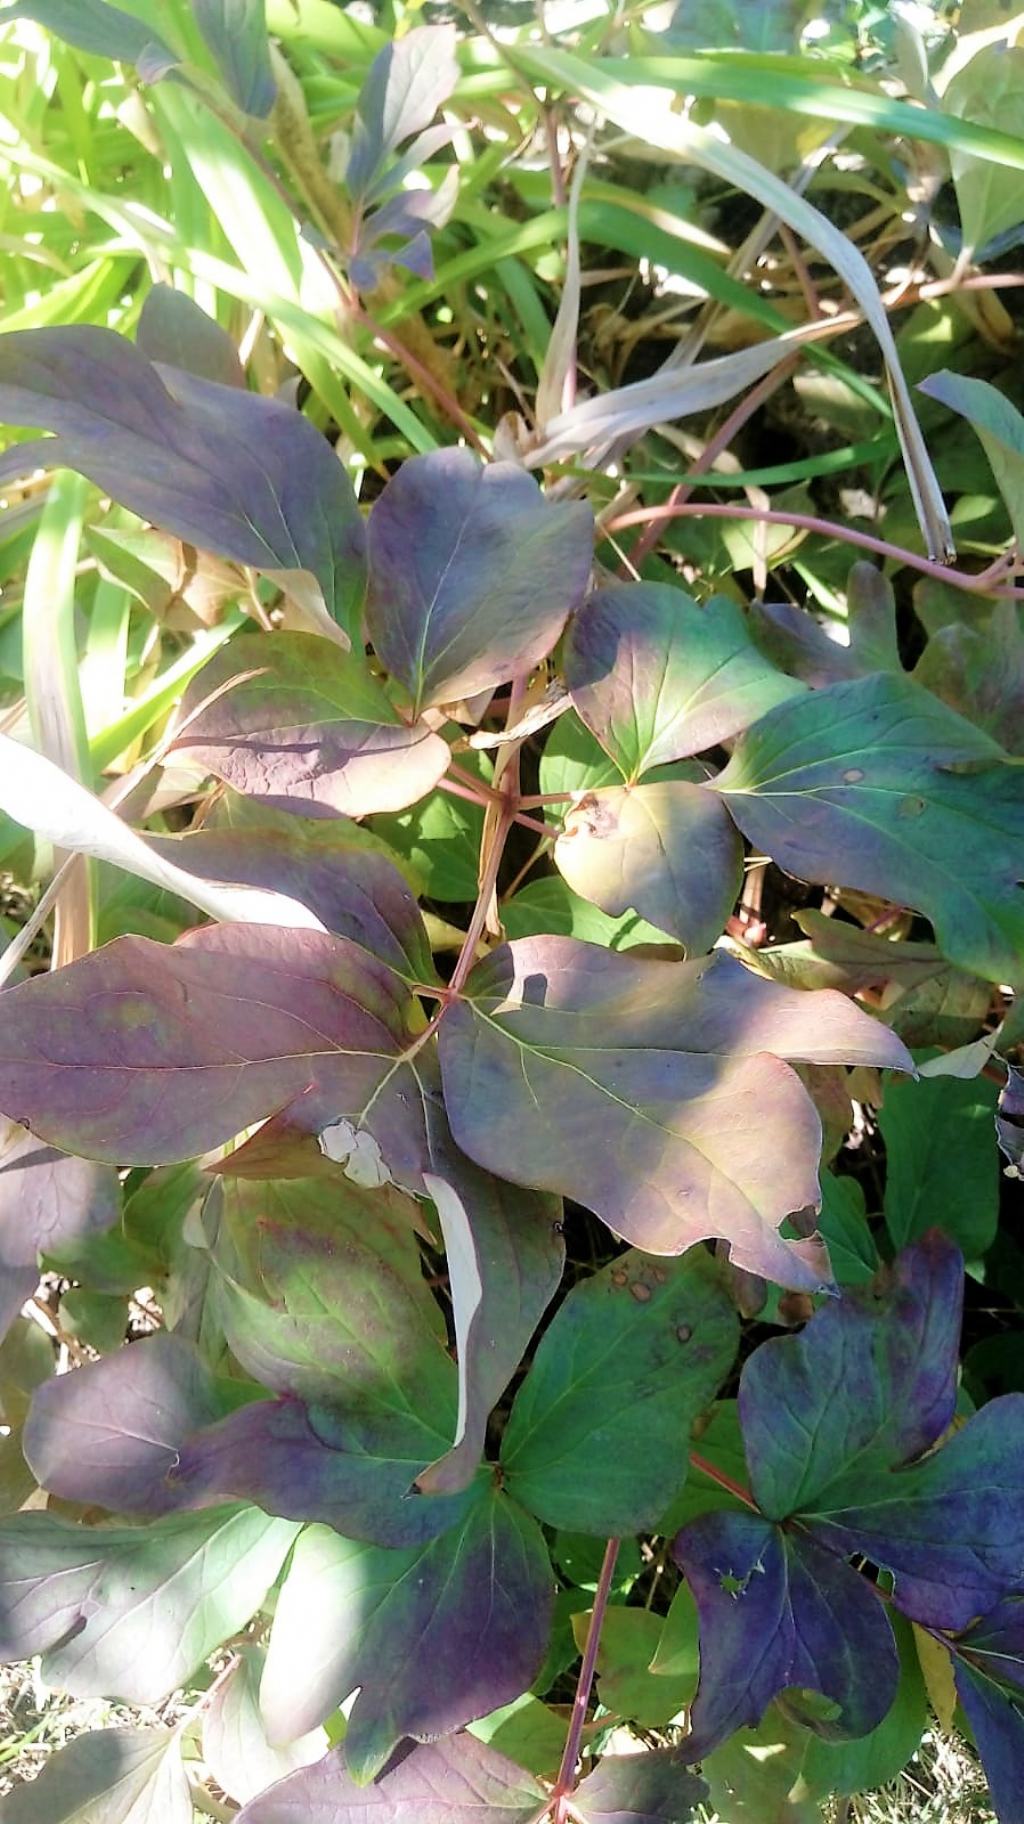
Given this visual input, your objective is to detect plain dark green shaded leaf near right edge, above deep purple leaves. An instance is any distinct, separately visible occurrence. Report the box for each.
[878,1076,1000,1260]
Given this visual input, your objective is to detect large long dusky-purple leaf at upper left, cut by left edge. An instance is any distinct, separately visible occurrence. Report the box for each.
[0,326,365,637]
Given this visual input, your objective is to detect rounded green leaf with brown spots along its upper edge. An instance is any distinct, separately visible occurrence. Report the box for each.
[502,1251,739,1536]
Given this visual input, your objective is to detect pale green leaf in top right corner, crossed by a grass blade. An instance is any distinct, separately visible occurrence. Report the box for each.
[942,44,1024,255]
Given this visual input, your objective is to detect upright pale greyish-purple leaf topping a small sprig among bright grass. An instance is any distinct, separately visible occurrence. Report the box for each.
[345,26,458,201]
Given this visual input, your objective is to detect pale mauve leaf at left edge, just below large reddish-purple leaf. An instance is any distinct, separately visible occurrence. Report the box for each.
[0,1116,120,1341]
